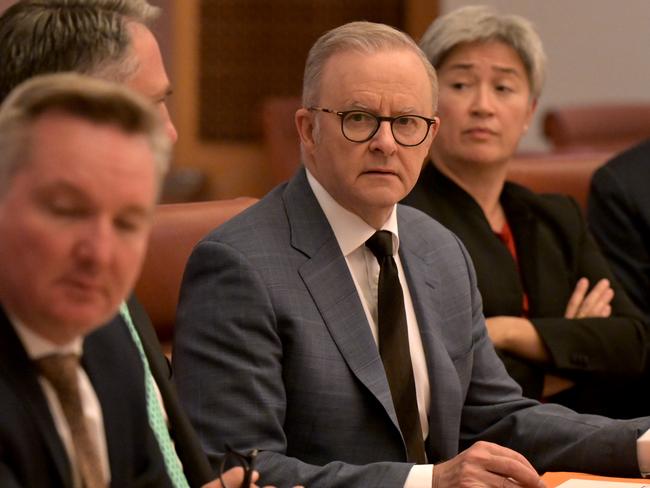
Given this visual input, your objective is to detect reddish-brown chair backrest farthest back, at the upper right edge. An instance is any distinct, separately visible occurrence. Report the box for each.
[544,102,650,152]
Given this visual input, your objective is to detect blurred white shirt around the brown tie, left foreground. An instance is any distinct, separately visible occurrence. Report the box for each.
[10,317,110,488]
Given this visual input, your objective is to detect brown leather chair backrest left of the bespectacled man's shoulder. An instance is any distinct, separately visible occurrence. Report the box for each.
[135,197,257,349]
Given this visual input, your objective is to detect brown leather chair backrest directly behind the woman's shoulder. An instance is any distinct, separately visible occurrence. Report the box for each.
[508,151,614,210]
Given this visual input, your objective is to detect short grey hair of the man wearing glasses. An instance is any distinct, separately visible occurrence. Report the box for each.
[302,21,438,113]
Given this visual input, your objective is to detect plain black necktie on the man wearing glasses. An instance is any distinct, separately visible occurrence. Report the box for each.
[366,230,426,464]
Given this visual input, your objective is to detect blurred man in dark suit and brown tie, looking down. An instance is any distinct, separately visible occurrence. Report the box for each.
[0,74,172,488]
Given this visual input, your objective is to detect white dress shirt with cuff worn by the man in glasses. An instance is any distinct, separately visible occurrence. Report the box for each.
[306,170,433,488]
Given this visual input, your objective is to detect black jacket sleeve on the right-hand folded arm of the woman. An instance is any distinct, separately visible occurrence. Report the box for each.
[531,196,646,377]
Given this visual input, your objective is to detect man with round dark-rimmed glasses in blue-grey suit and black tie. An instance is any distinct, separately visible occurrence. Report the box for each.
[174,22,650,488]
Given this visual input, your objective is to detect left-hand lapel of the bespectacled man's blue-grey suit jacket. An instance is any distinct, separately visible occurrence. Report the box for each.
[283,169,399,428]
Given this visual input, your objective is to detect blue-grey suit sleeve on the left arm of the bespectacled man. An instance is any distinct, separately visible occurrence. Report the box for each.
[173,241,411,488]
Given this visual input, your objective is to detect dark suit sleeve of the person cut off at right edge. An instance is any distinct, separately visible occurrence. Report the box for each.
[587,166,650,317]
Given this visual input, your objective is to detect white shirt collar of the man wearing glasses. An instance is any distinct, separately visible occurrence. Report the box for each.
[305,168,399,256]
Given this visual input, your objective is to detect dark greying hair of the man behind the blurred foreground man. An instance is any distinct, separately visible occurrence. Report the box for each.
[0,0,159,102]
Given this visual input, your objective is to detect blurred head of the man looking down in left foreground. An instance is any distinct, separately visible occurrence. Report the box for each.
[0,74,170,343]
